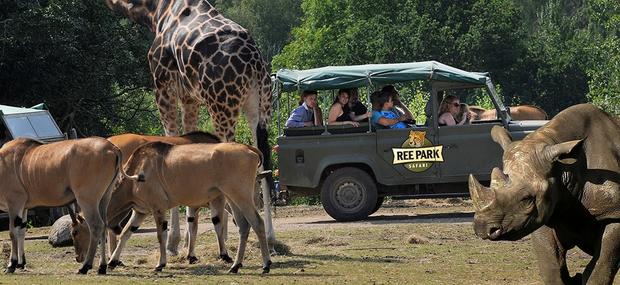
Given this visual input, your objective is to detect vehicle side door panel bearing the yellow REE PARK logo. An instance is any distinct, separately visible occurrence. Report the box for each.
[377,126,440,184]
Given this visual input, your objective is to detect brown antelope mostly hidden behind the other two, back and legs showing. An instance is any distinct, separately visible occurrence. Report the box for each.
[108,132,233,266]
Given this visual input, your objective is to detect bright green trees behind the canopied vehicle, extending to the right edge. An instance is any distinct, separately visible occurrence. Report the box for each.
[272,0,620,115]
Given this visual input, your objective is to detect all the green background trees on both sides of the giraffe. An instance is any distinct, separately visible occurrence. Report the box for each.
[0,0,620,144]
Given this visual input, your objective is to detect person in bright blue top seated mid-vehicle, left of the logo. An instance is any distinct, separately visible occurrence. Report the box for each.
[370,91,407,129]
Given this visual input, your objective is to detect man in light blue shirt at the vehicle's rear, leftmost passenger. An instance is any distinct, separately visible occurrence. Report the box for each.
[285,90,323,128]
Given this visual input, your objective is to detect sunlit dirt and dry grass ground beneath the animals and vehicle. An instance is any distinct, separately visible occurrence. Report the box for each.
[0,199,620,285]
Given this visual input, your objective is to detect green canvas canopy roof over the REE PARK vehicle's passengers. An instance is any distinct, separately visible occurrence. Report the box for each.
[276,61,488,91]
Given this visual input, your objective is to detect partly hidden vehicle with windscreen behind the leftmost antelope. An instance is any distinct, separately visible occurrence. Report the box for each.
[0,104,66,225]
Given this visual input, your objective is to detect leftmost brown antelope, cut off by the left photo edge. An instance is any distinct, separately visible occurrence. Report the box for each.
[0,138,135,274]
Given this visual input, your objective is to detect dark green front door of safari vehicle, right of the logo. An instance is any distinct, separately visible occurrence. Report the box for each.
[437,122,503,182]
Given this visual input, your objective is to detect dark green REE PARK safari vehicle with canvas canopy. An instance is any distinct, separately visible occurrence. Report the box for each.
[274,61,546,221]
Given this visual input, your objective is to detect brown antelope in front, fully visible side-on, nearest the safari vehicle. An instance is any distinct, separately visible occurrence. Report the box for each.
[74,142,271,273]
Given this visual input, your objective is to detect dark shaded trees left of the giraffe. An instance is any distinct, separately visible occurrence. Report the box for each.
[0,0,150,136]
